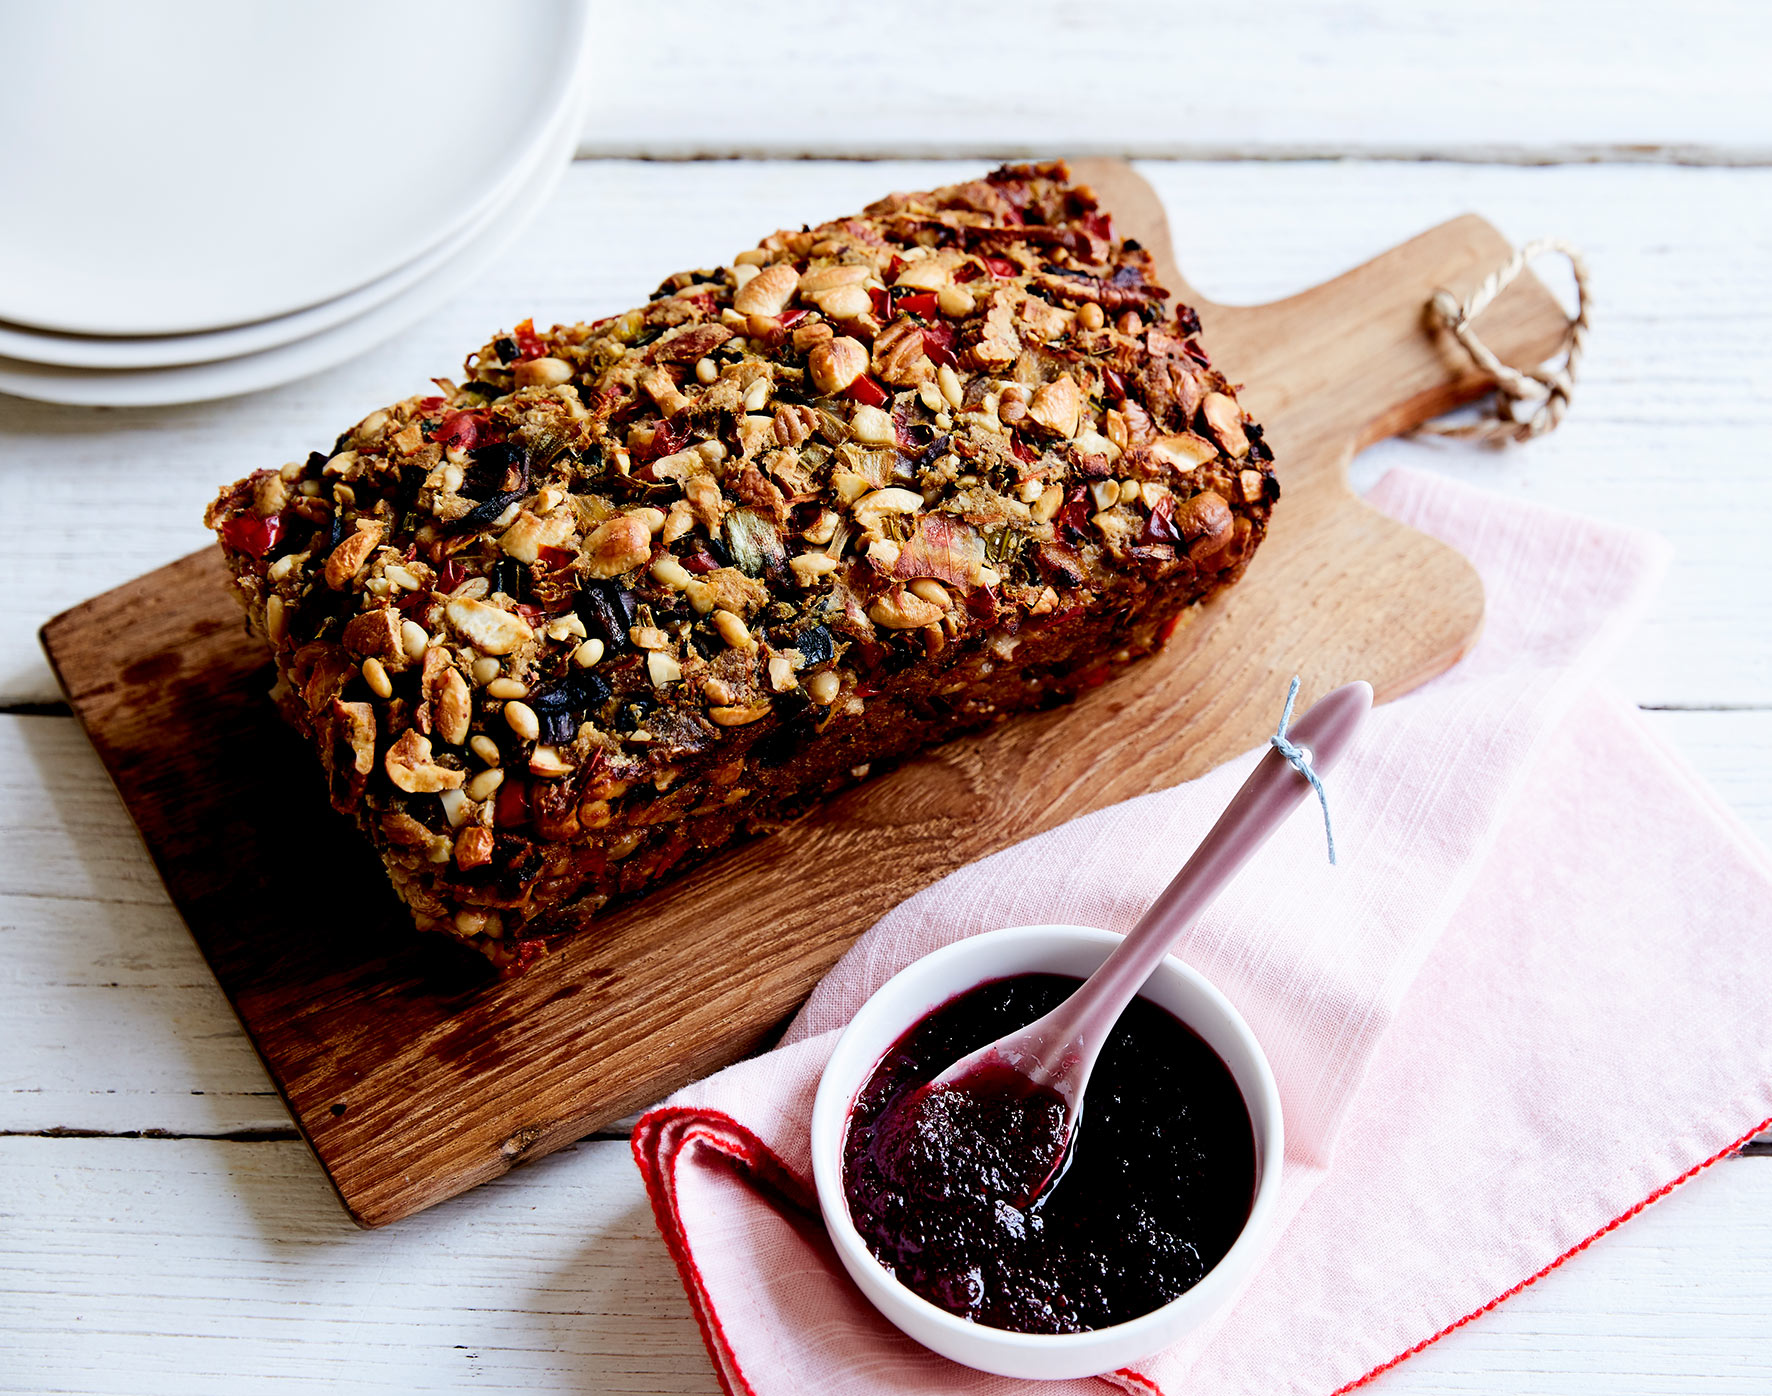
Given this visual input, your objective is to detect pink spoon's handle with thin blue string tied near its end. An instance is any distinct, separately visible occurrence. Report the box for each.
[1042,682,1372,1072]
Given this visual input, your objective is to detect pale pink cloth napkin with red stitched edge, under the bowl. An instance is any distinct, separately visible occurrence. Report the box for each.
[634,471,1772,1396]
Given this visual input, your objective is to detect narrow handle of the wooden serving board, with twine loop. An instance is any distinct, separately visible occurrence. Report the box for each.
[1198,213,1568,450]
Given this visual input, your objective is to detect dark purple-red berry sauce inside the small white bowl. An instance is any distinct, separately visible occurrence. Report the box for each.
[843,974,1255,1332]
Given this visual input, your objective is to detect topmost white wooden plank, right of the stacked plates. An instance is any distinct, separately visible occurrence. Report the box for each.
[579,0,1772,161]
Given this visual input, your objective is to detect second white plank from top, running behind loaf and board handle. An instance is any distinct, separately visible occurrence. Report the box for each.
[0,163,1772,703]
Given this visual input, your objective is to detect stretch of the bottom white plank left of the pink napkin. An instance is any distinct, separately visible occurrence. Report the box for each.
[0,1139,718,1396]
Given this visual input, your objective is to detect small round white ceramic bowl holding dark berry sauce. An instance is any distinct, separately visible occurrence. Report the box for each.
[812,927,1285,1380]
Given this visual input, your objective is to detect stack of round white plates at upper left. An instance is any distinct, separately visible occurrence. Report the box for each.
[0,0,588,406]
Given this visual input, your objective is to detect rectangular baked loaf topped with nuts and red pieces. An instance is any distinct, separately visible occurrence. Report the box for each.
[207,165,1279,969]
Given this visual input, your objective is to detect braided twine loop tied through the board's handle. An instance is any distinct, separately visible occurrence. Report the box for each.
[1418,237,1591,446]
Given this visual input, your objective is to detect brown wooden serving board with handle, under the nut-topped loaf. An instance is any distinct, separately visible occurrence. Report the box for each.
[43,161,1565,1226]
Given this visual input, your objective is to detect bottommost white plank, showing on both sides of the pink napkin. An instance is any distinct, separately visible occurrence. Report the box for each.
[0,1139,1772,1396]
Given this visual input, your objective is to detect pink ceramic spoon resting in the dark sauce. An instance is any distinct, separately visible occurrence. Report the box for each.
[927,682,1372,1201]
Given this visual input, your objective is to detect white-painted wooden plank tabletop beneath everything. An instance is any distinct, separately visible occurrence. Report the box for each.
[0,0,1772,1394]
